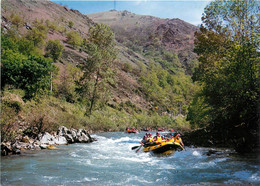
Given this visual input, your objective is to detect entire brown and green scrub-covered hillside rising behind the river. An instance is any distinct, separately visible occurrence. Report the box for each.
[1,0,197,144]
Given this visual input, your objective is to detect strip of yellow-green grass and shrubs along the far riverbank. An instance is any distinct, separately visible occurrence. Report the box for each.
[1,91,190,141]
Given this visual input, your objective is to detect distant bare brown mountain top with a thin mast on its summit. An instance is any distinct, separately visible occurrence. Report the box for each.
[88,10,199,74]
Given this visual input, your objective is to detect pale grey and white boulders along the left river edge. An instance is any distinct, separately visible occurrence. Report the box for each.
[1,126,96,156]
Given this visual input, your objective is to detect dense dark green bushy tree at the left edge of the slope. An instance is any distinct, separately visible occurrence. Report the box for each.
[1,49,54,99]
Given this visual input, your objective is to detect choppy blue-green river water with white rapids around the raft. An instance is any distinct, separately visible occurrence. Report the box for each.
[1,132,260,186]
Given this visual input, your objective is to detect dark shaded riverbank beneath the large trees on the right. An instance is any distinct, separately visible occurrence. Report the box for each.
[182,125,260,153]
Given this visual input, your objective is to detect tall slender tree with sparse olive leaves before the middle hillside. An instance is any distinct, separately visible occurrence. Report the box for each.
[78,24,117,114]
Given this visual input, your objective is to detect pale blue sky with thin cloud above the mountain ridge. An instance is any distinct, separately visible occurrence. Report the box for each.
[52,0,210,26]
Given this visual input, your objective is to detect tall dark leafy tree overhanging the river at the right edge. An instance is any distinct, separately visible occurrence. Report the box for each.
[190,0,259,150]
